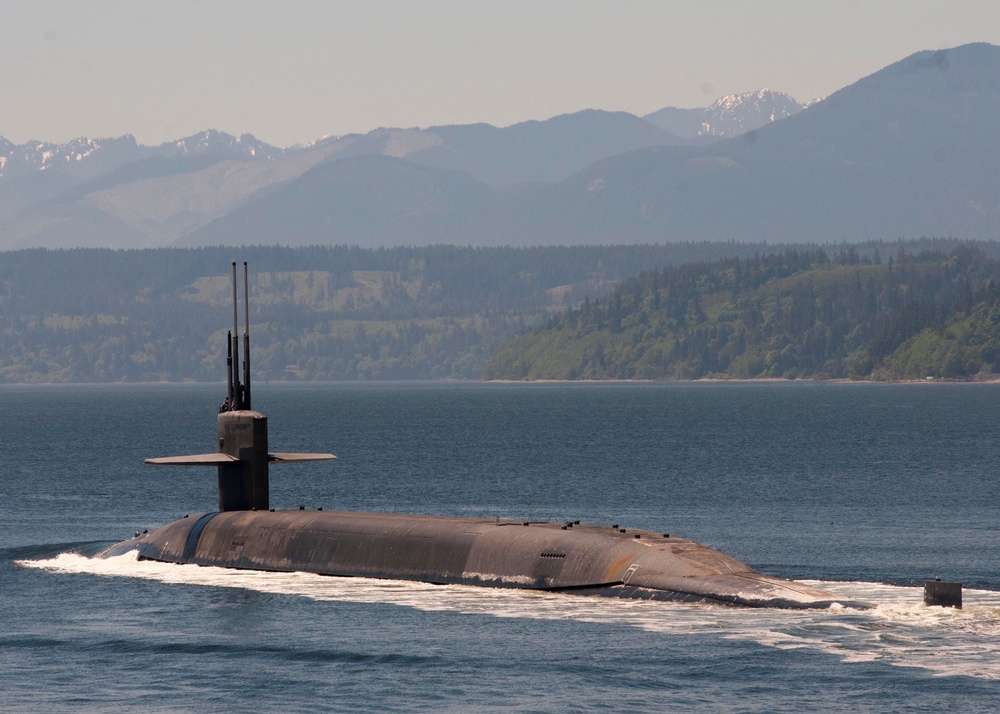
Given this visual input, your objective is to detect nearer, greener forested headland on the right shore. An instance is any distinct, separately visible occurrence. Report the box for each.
[485,244,1000,379]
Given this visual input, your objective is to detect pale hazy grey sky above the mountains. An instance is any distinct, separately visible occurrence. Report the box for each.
[0,0,1000,146]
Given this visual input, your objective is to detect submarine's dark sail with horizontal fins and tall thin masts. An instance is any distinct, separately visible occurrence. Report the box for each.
[146,261,336,511]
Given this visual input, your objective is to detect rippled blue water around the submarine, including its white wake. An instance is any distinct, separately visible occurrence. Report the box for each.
[0,383,1000,712]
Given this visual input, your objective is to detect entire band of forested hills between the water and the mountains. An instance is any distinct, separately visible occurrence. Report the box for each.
[0,240,1000,383]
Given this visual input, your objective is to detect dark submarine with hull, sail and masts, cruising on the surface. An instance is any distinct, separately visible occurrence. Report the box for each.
[97,262,867,609]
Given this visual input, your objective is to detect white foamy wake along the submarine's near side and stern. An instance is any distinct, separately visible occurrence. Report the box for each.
[18,553,1000,680]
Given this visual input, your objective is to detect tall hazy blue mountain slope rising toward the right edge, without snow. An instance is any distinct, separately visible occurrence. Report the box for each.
[528,44,1000,242]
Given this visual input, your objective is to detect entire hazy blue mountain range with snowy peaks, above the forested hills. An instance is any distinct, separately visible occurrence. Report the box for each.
[0,44,1000,249]
